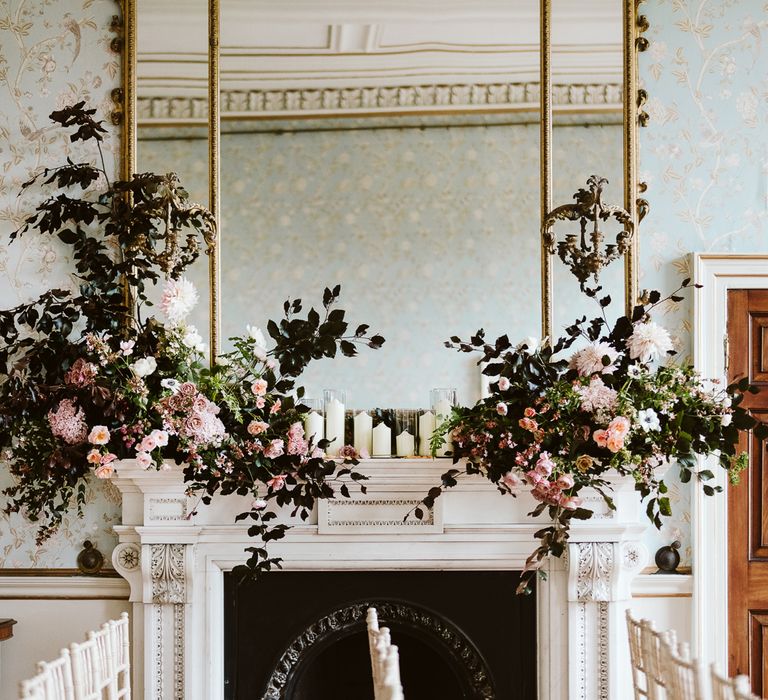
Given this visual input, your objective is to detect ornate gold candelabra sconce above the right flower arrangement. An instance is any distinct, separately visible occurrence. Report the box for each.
[542,175,635,292]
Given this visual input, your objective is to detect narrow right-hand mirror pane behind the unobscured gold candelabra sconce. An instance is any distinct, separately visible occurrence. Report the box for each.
[551,0,624,336]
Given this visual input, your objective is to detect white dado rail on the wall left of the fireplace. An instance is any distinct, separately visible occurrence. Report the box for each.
[0,575,129,600]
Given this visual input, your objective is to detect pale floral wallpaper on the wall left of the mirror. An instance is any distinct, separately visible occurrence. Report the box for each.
[0,0,120,568]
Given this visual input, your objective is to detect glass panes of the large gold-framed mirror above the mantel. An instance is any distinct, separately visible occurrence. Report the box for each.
[132,0,623,408]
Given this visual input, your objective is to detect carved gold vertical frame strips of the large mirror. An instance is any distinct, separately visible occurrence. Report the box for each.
[121,0,648,358]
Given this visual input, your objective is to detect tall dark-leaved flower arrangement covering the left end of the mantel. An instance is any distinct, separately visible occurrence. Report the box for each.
[0,102,384,572]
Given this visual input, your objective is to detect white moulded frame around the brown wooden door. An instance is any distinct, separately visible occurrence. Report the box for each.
[691,253,768,670]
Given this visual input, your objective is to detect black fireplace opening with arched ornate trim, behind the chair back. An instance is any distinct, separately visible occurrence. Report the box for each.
[224,571,536,700]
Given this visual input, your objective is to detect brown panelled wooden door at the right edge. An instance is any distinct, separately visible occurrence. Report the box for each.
[728,289,768,697]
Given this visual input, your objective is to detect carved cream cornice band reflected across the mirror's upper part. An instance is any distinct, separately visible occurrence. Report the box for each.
[138,83,622,125]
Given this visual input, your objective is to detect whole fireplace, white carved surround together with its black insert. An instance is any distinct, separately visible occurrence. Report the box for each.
[112,459,648,700]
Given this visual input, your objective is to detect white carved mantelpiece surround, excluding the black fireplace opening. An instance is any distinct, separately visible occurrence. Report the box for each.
[112,459,648,700]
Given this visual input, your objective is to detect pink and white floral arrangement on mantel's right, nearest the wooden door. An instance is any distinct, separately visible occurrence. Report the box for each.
[416,279,768,593]
